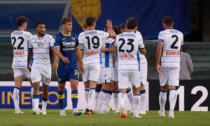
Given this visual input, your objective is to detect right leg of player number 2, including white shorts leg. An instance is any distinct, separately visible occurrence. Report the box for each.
[168,68,180,118]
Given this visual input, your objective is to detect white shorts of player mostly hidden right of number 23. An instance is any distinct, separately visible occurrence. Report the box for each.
[140,62,148,85]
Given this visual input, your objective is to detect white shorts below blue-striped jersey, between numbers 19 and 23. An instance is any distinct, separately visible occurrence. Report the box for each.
[99,68,113,84]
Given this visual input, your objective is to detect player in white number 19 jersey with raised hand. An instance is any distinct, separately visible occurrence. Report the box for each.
[78,17,115,114]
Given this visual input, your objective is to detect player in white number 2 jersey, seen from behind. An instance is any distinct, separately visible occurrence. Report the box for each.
[156,16,184,118]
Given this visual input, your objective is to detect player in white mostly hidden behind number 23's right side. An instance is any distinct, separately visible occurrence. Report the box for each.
[136,31,148,114]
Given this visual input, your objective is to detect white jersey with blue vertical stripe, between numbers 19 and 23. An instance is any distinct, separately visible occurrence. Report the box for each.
[101,38,115,68]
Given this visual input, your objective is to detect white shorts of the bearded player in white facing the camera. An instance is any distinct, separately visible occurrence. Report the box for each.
[31,67,52,85]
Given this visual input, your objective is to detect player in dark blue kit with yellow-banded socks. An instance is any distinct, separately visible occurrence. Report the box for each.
[53,18,84,116]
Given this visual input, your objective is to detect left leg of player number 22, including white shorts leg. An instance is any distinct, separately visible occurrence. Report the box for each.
[13,69,23,114]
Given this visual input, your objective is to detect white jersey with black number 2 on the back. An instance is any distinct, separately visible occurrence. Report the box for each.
[158,29,184,67]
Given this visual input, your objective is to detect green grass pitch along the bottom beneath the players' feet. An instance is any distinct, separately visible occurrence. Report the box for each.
[0,109,210,126]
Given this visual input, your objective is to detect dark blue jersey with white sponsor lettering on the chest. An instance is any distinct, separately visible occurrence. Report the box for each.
[54,32,79,70]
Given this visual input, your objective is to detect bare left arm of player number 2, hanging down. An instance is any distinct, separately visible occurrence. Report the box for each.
[156,43,163,74]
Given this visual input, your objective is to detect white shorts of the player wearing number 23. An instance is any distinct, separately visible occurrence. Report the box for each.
[118,71,141,89]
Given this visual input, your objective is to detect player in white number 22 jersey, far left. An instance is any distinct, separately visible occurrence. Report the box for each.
[11,16,33,114]
